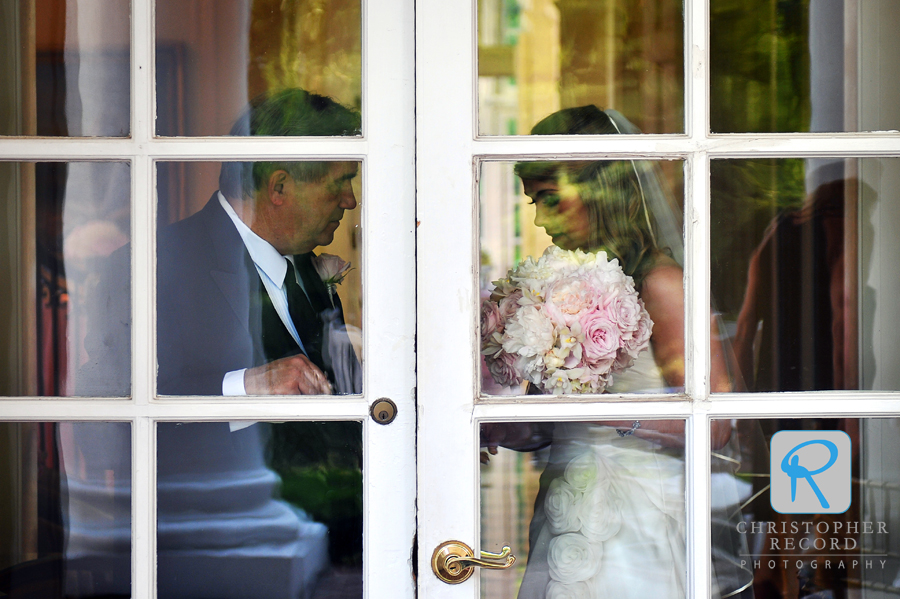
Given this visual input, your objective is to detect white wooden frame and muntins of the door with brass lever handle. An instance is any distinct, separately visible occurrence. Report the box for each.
[416,0,900,599]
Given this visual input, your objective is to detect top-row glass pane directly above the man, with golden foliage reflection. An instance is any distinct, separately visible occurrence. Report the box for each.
[156,0,362,136]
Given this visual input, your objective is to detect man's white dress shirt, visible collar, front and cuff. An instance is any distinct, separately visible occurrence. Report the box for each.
[217,191,309,395]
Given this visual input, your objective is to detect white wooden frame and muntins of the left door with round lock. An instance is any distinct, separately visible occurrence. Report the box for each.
[0,0,415,599]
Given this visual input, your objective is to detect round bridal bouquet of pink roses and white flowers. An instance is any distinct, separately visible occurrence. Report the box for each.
[481,246,653,395]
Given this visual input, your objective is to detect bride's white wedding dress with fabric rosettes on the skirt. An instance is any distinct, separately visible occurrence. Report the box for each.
[519,350,686,599]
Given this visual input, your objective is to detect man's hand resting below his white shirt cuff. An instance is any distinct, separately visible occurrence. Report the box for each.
[244,354,334,395]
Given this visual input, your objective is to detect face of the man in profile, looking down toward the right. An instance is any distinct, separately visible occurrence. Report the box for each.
[273,162,359,254]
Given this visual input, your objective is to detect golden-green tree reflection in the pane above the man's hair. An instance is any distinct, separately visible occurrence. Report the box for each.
[249,0,362,109]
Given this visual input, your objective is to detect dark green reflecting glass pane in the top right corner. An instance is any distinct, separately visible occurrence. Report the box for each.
[709,0,900,133]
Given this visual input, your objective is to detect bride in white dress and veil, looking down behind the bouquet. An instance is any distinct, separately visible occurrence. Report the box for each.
[488,106,730,599]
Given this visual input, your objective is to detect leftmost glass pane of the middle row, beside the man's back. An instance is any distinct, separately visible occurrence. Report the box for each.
[0,162,131,397]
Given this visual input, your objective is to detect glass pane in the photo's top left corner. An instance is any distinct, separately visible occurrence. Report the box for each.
[0,0,131,137]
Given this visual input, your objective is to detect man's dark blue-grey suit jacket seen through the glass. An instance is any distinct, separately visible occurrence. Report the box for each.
[86,194,359,395]
